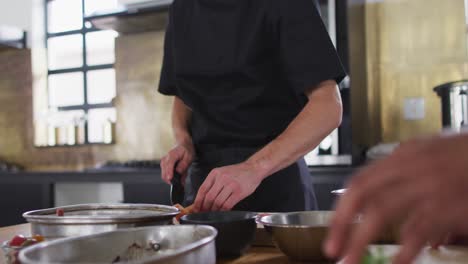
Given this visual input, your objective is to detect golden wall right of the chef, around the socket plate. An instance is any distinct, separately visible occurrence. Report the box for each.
[349,0,468,146]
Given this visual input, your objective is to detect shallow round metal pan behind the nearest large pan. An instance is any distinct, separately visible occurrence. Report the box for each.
[23,204,179,239]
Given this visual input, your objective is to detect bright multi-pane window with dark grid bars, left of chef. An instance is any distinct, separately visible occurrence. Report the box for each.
[45,0,118,145]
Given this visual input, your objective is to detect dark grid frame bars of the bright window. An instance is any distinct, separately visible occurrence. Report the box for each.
[44,0,117,145]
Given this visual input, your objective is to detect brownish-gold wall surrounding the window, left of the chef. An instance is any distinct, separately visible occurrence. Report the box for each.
[0,32,173,170]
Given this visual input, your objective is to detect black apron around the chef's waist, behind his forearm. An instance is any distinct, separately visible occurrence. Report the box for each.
[185,148,317,212]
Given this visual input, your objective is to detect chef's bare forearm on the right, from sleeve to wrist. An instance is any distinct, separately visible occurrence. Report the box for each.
[247,81,342,179]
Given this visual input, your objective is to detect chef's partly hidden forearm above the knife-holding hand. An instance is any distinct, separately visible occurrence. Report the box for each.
[172,97,192,144]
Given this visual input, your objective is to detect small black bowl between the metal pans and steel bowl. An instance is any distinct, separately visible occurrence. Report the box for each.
[180,211,257,257]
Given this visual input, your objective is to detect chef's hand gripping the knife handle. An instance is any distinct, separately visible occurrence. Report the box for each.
[161,141,195,184]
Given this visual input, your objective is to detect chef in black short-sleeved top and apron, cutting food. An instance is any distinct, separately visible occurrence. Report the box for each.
[159,0,346,212]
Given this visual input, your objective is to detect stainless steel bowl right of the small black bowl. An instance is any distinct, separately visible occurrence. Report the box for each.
[257,211,333,261]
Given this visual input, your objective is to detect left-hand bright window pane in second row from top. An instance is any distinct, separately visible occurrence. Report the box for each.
[47,34,83,70]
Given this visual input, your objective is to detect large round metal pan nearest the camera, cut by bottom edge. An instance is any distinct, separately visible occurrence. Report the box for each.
[19,225,217,264]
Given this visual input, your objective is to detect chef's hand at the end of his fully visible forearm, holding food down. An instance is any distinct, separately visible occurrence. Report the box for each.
[194,162,262,211]
